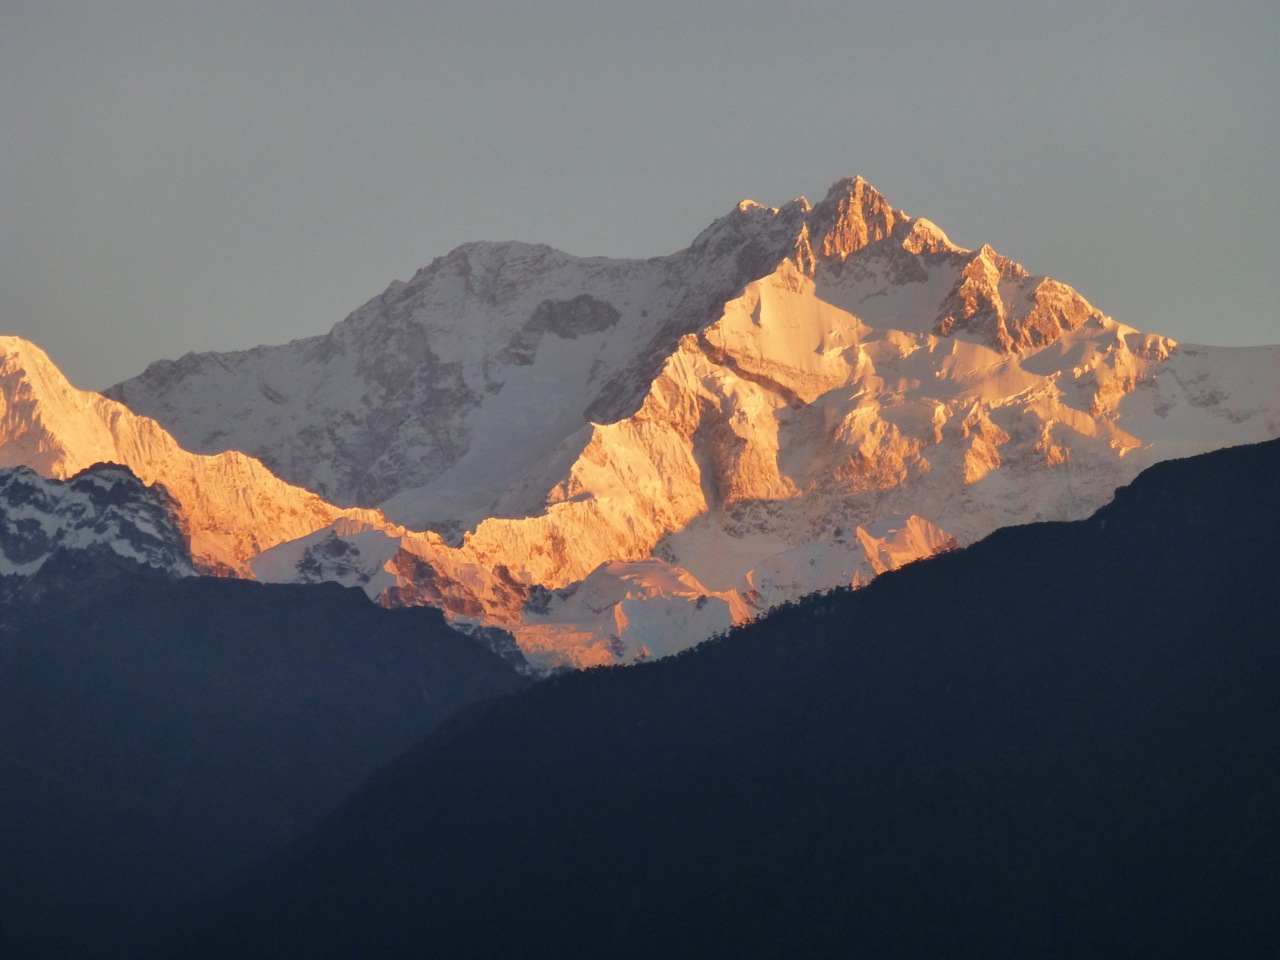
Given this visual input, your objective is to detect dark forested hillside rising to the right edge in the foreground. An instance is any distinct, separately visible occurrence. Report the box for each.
[180,443,1280,957]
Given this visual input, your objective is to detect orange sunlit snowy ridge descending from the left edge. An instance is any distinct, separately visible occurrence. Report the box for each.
[0,337,379,575]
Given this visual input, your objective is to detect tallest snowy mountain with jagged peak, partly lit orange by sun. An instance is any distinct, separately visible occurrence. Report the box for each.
[109,178,1280,667]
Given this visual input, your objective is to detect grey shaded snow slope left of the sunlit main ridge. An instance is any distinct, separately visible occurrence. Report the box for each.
[108,206,814,531]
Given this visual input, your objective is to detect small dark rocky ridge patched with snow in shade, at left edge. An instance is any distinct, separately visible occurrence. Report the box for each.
[0,463,196,576]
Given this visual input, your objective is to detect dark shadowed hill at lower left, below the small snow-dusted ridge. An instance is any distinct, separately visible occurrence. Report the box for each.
[0,550,529,959]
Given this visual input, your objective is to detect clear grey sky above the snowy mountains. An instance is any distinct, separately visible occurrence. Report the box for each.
[0,0,1280,388]
